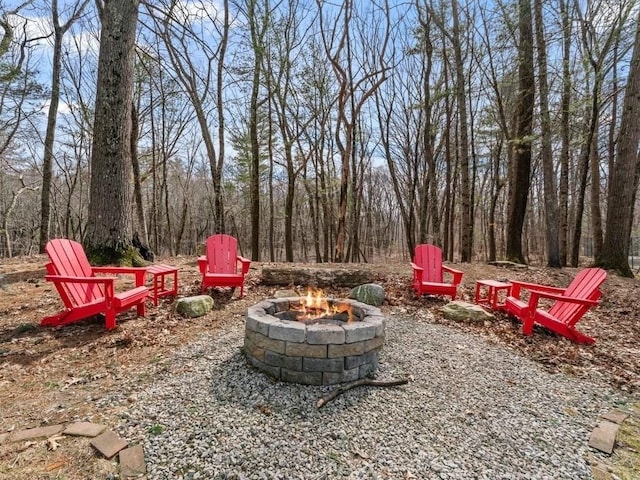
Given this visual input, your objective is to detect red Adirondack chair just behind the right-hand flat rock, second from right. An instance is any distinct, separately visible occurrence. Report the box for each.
[411,243,464,300]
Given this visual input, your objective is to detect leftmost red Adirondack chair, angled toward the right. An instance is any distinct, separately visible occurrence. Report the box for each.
[40,238,149,330]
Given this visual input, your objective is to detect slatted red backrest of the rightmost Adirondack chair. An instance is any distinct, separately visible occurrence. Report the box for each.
[549,268,607,326]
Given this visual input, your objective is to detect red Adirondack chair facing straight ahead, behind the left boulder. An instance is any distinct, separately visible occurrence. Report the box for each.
[198,234,251,297]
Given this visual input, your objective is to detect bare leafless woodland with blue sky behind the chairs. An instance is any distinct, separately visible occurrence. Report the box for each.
[0,0,640,276]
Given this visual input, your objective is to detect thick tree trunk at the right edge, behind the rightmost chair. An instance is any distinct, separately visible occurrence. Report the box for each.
[596,7,640,277]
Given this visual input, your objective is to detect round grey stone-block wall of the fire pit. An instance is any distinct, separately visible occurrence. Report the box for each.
[244,298,385,385]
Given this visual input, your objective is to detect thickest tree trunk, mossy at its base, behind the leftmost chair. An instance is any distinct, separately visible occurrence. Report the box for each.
[85,0,139,264]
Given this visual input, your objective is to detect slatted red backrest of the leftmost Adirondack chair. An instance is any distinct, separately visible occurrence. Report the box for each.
[45,238,104,307]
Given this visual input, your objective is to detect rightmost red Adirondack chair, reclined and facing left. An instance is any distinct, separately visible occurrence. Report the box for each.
[505,268,607,344]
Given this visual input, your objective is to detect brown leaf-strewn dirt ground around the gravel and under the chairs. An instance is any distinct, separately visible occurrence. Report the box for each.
[0,256,640,480]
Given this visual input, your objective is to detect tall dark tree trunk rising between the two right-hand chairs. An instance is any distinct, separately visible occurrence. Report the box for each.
[506,0,535,263]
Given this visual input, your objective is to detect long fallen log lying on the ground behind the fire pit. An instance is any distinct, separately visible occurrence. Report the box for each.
[262,265,379,287]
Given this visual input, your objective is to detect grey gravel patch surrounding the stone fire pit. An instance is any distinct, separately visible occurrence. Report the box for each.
[112,310,625,480]
